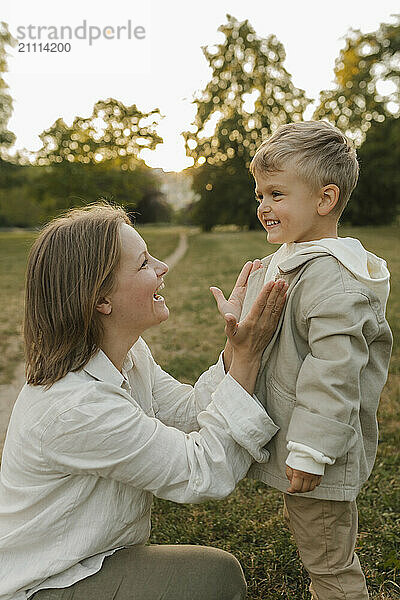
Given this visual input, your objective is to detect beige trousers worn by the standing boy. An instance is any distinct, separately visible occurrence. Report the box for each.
[283,494,368,600]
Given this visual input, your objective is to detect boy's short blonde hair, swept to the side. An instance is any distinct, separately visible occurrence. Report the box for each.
[250,121,359,217]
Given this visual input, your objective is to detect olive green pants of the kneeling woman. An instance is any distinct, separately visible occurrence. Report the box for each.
[31,545,246,600]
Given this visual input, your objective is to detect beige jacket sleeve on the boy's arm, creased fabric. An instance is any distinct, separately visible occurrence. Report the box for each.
[287,292,379,459]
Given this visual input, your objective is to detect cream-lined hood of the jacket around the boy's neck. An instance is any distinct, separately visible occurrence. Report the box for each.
[266,237,390,311]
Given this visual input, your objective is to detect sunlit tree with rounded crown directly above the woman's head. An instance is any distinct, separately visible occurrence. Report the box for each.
[24,98,166,223]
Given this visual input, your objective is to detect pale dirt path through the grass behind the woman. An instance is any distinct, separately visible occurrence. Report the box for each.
[0,233,188,451]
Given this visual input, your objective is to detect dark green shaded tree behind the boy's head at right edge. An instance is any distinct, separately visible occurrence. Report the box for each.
[343,117,400,225]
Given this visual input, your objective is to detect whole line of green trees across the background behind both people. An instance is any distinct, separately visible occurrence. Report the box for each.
[0,15,400,231]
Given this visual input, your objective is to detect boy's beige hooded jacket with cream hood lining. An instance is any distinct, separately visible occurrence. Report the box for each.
[242,238,392,500]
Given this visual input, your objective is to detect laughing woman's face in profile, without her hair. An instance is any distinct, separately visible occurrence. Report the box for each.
[109,223,169,335]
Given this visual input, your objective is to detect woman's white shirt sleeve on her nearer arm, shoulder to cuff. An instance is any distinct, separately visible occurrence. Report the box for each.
[41,375,278,502]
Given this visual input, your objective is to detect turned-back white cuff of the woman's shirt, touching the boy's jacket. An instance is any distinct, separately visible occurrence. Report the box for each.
[213,373,279,462]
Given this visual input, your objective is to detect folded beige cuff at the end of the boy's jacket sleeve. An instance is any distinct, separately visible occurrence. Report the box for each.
[286,406,358,458]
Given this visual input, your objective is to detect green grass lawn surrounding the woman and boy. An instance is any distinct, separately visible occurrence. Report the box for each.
[0,227,400,600]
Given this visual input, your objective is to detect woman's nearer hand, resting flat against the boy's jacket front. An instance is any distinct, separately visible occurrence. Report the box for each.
[225,280,288,394]
